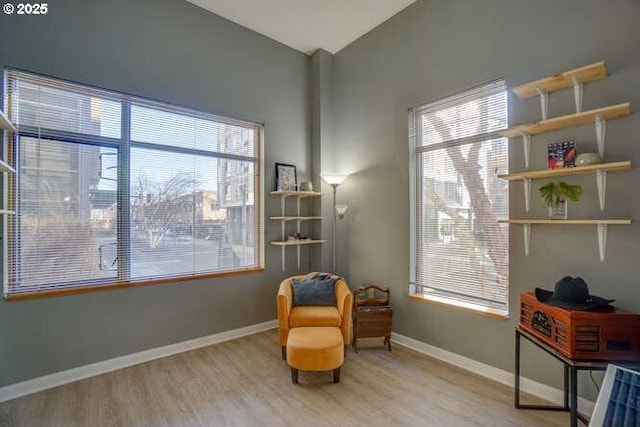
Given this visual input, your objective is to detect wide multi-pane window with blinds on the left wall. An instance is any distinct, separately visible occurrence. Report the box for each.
[4,70,263,298]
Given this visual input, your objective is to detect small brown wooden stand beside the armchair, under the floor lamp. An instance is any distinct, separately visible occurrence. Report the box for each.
[353,285,393,353]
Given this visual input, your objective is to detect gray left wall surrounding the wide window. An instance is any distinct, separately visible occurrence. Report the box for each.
[0,0,311,386]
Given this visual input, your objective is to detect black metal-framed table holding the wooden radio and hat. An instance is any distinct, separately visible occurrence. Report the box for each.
[514,326,640,427]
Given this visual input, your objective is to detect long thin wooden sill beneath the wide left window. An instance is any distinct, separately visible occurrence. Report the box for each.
[5,267,264,301]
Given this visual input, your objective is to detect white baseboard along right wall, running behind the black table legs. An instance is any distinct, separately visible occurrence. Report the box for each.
[391,332,595,414]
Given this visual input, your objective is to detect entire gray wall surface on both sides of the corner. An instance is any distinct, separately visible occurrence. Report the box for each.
[0,0,640,400]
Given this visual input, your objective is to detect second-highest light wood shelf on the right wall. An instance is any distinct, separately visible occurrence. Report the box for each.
[500,102,631,138]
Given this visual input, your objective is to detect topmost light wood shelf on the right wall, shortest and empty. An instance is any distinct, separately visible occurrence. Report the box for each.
[513,61,607,99]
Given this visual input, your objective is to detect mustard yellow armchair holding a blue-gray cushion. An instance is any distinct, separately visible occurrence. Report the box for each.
[277,276,353,359]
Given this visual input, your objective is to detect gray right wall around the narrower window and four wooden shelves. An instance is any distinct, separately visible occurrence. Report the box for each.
[333,0,640,391]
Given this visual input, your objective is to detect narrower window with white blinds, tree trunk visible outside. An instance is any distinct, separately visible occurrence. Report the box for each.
[409,80,509,317]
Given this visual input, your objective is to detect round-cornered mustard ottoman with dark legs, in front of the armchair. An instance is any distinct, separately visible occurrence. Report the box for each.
[287,326,344,384]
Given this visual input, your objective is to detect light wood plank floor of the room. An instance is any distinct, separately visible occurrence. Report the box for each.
[0,330,569,427]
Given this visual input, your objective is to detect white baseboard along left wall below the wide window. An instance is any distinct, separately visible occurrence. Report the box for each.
[0,320,278,402]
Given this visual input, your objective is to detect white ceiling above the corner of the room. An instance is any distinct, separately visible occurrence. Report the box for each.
[187,0,416,55]
